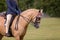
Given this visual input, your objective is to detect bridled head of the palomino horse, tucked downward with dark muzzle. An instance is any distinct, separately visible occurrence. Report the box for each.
[32,9,43,28]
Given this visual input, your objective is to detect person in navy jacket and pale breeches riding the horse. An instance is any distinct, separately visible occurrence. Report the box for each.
[6,0,21,36]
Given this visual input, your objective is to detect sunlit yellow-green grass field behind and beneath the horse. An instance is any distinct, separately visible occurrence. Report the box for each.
[3,18,60,40]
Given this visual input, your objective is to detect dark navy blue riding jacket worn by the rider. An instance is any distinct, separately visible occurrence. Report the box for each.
[6,0,21,15]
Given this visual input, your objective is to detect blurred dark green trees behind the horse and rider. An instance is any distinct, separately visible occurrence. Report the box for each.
[0,0,60,17]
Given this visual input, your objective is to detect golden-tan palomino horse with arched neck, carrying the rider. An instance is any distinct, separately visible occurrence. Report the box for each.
[0,9,42,40]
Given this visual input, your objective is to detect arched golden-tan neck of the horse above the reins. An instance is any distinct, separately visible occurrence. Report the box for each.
[22,9,38,20]
